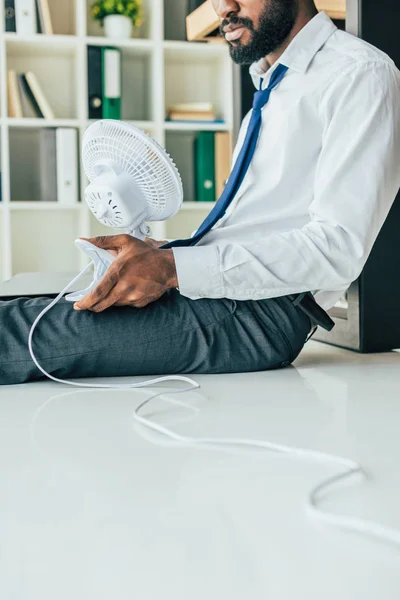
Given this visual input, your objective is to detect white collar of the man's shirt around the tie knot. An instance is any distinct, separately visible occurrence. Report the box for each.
[250,11,337,89]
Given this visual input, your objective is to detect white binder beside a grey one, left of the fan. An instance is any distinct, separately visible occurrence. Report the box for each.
[56,127,78,206]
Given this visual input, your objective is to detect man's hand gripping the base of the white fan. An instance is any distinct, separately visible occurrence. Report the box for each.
[74,235,178,312]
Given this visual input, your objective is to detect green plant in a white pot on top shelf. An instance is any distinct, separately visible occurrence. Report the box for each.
[91,0,143,40]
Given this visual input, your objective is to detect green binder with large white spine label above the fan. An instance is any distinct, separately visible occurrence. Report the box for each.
[102,47,122,120]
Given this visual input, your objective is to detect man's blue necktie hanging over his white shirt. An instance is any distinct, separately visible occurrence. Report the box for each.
[162,64,288,249]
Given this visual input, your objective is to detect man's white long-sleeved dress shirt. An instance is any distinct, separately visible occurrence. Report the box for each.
[174,12,400,309]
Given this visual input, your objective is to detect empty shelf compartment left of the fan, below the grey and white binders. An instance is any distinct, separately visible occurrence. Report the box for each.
[11,210,79,274]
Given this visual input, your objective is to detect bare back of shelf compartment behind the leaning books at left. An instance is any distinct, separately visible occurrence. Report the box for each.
[7,36,79,119]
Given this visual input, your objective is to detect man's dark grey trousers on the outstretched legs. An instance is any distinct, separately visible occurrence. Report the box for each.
[0,289,311,385]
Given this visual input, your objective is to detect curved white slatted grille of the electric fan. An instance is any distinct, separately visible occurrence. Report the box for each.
[82,120,183,221]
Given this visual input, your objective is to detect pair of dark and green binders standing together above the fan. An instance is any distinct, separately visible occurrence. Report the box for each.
[88,46,122,120]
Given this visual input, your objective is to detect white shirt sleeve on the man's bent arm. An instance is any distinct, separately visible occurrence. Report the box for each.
[173,61,400,300]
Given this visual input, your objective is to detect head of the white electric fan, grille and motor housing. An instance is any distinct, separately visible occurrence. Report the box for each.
[82,120,183,239]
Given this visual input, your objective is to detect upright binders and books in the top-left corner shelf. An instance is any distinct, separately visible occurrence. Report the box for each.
[5,0,54,36]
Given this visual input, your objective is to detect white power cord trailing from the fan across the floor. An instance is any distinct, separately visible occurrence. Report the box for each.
[28,264,400,548]
